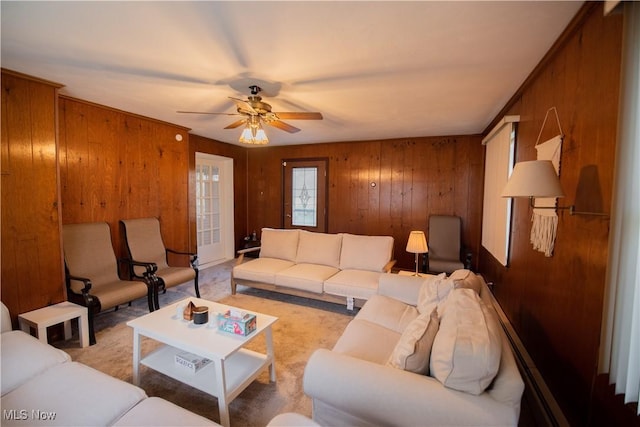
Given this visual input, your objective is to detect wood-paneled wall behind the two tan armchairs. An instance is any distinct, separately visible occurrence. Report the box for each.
[59,97,196,265]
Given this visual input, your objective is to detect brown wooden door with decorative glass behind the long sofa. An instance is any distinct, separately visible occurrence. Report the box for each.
[282,159,328,233]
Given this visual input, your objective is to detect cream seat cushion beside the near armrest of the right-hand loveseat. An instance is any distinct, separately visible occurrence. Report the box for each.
[333,319,402,365]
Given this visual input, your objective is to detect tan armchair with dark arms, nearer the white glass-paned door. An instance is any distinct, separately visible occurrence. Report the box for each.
[120,218,200,308]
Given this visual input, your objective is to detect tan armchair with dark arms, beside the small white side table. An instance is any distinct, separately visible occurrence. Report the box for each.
[62,222,156,344]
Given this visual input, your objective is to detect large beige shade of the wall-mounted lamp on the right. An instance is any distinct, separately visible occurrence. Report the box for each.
[502,160,564,197]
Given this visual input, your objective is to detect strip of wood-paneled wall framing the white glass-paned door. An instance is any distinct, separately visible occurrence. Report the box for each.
[189,135,249,254]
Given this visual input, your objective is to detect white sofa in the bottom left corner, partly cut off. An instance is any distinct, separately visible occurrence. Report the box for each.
[0,304,218,426]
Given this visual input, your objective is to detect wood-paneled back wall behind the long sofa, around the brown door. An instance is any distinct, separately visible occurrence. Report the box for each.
[247,135,484,269]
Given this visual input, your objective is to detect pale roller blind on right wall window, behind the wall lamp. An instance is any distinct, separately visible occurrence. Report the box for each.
[482,116,520,266]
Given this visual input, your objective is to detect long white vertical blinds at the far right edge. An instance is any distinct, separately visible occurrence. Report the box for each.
[598,2,640,415]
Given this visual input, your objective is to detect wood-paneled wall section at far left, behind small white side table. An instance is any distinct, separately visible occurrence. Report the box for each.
[1,70,66,320]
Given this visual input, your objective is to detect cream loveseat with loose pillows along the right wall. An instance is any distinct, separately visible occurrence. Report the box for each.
[304,270,524,427]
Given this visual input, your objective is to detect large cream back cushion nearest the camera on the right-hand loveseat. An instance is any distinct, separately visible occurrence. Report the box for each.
[430,289,502,395]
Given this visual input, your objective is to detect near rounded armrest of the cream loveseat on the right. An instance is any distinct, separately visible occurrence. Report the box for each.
[304,349,518,426]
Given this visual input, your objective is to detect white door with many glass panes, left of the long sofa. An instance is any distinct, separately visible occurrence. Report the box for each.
[196,153,235,268]
